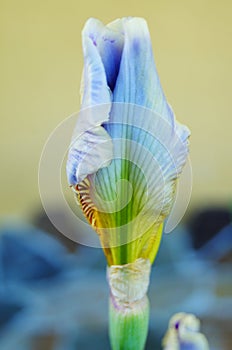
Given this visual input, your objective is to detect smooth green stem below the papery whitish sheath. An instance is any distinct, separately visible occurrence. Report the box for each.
[109,296,149,350]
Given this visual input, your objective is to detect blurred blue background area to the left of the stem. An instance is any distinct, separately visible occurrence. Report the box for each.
[0,225,107,350]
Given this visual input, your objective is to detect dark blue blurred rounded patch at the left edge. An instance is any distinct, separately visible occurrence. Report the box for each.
[0,227,66,283]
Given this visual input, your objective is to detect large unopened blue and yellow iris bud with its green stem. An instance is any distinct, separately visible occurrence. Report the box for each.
[67,17,190,350]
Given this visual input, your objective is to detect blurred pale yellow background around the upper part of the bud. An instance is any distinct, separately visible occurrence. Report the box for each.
[0,0,232,216]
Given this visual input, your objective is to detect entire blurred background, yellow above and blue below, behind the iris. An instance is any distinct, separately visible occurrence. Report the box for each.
[0,0,232,350]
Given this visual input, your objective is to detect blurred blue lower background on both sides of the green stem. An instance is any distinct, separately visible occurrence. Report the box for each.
[0,221,232,350]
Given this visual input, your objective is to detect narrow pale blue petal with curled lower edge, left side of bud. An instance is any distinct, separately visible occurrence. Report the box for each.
[66,19,113,186]
